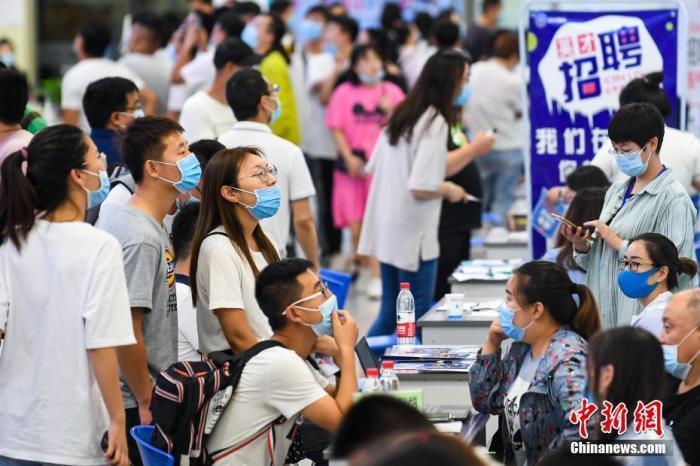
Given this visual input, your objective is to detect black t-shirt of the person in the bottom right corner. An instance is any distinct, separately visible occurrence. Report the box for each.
[663,376,700,465]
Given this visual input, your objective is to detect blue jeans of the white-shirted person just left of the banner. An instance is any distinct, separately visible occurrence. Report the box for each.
[476,149,523,226]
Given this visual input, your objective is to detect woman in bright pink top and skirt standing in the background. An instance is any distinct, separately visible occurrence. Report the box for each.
[326,45,404,298]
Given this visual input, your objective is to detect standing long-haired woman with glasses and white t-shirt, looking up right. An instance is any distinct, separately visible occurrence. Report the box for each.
[190,147,280,353]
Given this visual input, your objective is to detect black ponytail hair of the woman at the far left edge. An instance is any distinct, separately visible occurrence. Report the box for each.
[0,125,88,249]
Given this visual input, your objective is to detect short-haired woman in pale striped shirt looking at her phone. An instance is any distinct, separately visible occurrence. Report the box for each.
[560,103,696,327]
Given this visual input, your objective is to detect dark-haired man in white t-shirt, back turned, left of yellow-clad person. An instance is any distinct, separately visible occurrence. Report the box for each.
[180,38,260,142]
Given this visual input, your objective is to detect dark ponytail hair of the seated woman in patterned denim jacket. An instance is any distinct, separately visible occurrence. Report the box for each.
[513,261,601,340]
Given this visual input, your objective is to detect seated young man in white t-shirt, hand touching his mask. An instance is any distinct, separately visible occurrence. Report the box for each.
[207,259,358,466]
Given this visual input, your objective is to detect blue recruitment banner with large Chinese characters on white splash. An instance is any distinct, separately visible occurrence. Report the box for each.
[525,9,680,258]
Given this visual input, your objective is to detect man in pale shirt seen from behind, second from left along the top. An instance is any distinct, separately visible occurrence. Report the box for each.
[119,13,173,115]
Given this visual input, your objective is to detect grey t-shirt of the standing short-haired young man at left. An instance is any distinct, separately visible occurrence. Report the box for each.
[97,204,177,408]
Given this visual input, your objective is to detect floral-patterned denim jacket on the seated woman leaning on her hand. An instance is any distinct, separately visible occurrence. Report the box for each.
[469,326,588,465]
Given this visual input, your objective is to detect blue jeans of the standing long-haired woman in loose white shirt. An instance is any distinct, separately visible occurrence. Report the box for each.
[367,259,438,336]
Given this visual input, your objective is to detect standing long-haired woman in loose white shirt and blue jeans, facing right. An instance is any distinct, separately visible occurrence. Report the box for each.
[358,51,476,335]
